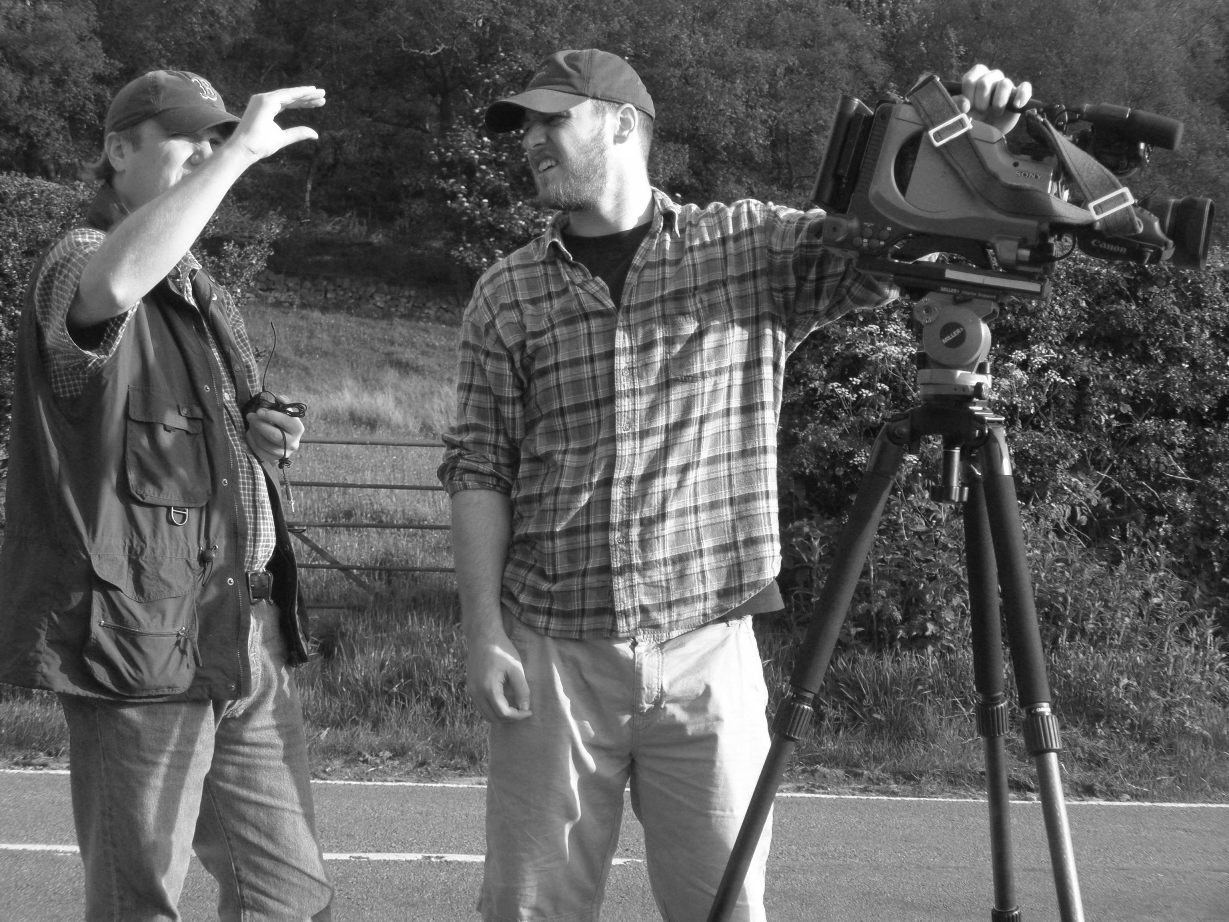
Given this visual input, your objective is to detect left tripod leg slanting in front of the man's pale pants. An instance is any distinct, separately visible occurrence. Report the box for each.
[708,417,909,922]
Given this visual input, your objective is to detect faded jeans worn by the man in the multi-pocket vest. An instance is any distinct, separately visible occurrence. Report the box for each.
[60,602,332,922]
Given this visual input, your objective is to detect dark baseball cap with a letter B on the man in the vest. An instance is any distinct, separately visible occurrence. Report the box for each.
[104,70,238,134]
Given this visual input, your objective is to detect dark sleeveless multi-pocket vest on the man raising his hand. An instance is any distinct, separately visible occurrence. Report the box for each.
[0,188,306,699]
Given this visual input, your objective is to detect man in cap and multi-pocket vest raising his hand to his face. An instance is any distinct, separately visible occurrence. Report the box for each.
[0,70,332,922]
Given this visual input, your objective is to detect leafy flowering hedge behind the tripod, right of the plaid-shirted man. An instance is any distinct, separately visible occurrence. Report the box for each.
[780,249,1229,649]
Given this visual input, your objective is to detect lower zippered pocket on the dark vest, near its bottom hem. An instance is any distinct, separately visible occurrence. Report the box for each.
[82,558,199,697]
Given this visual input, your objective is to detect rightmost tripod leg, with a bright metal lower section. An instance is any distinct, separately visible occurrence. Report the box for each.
[981,425,1084,922]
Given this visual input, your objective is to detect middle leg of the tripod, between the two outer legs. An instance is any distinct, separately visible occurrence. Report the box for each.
[964,463,1020,922]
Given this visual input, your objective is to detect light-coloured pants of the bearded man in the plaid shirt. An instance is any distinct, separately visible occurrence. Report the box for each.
[479,616,772,922]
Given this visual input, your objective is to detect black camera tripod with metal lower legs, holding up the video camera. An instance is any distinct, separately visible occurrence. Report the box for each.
[708,290,1084,922]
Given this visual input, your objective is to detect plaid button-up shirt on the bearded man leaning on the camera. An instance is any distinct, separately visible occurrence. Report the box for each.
[440,192,889,638]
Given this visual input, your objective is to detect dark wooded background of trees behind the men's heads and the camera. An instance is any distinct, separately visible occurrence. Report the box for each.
[0,0,1229,260]
